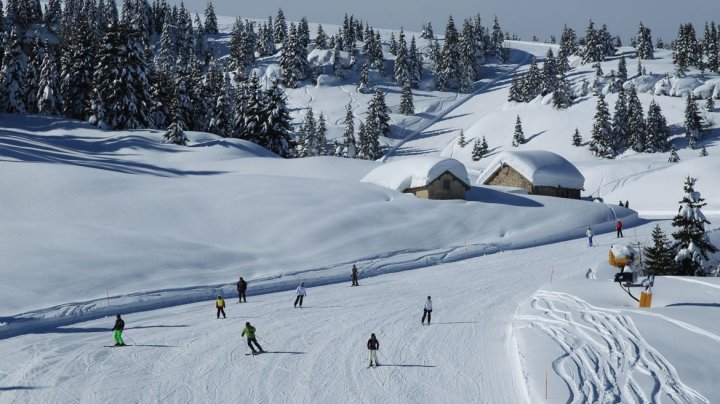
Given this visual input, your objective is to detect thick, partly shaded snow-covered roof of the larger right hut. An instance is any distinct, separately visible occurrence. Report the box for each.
[477,150,585,189]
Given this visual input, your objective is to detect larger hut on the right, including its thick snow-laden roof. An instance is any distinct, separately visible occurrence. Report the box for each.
[477,150,585,199]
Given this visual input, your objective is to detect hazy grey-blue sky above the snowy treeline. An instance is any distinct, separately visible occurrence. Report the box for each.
[173,0,720,43]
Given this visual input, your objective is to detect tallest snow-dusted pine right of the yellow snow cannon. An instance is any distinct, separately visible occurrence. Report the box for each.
[672,177,718,276]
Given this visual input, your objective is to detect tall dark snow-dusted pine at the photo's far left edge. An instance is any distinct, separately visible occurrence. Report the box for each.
[0,26,27,113]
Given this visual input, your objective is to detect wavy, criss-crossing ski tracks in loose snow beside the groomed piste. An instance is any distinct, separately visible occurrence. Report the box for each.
[518,291,709,403]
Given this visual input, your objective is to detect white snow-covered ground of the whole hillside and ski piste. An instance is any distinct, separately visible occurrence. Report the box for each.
[0,23,720,403]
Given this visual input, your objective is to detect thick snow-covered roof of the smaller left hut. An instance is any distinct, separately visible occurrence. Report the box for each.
[361,156,470,192]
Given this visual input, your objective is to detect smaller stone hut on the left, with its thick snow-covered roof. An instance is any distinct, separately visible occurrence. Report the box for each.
[361,156,470,199]
